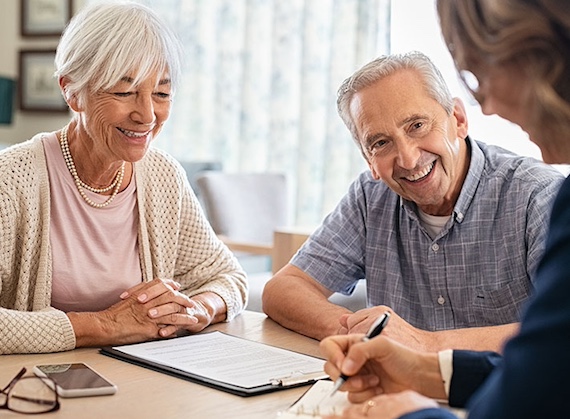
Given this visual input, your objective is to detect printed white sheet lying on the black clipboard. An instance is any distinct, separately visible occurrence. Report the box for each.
[109,332,327,388]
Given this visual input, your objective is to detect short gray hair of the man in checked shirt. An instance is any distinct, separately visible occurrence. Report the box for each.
[336,51,453,151]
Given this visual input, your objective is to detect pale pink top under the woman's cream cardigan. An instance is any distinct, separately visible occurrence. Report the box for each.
[43,134,142,312]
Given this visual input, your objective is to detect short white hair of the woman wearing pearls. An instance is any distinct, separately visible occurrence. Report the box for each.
[55,2,182,106]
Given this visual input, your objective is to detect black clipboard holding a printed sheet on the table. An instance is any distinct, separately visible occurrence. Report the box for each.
[100,331,328,397]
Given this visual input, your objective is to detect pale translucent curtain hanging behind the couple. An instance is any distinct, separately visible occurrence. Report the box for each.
[98,0,390,225]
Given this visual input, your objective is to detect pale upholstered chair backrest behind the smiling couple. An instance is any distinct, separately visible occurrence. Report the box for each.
[196,172,289,245]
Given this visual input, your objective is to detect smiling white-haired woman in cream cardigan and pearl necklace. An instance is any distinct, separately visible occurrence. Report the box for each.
[0,3,247,354]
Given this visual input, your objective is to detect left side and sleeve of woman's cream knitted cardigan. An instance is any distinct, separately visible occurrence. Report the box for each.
[0,139,75,354]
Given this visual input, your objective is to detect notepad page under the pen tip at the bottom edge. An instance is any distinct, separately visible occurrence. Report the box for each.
[277,380,350,419]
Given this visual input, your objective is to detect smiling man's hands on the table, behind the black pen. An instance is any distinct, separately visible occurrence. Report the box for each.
[339,306,436,351]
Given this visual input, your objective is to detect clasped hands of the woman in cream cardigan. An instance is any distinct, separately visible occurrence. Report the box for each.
[111,279,212,338]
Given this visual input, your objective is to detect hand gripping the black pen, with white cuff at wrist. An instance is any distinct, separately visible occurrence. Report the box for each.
[320,334,446,403]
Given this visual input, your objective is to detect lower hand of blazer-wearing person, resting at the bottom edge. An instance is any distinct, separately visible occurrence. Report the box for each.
[327,390,438,419]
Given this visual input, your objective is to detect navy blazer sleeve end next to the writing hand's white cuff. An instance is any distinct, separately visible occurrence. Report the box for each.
[449,350,502,407]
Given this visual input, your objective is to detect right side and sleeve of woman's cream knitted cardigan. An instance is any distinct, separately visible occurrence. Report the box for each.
[136,150,248,321]
